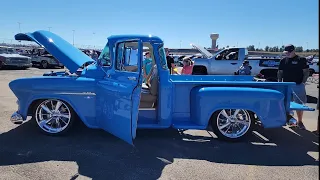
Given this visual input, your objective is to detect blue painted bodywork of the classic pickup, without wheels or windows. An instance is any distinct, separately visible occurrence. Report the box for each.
[9,31,314,144]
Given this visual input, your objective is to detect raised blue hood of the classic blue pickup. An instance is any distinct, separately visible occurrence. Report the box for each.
[14,30,94,73]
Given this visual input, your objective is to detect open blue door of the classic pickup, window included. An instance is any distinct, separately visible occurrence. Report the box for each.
[97,40,142,144]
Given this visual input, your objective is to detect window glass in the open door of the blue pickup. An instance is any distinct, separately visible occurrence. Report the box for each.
[116,42,139,72]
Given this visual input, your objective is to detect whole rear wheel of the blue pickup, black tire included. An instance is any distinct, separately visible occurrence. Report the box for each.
[211,109,254,142]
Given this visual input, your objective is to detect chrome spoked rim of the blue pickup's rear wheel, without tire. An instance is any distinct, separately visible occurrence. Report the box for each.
[216,109,251,139]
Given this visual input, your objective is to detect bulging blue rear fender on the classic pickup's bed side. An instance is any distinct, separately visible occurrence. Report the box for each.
[191,87,286,128]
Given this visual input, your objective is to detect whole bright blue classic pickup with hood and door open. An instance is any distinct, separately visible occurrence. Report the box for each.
[9,31,314,144]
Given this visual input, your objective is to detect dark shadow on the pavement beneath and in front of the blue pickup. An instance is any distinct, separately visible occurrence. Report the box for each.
[0,119,319,179]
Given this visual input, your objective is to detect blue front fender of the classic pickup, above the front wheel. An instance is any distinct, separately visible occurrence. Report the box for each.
[9,76,96,128]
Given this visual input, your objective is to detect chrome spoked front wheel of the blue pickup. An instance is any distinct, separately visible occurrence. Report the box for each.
[35,99,72,134]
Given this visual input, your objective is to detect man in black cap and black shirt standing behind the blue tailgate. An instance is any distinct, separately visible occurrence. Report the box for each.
[278,44,309,129]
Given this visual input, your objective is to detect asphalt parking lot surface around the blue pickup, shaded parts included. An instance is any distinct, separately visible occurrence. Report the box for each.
[0,68,319,180]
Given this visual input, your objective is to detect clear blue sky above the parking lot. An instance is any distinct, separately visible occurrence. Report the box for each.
[0,0,319,49]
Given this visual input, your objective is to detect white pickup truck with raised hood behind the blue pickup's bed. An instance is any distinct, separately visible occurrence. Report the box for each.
[192,44,281,78]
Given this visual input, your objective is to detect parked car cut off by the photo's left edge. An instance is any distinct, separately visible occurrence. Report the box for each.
[0,46,32,69]
